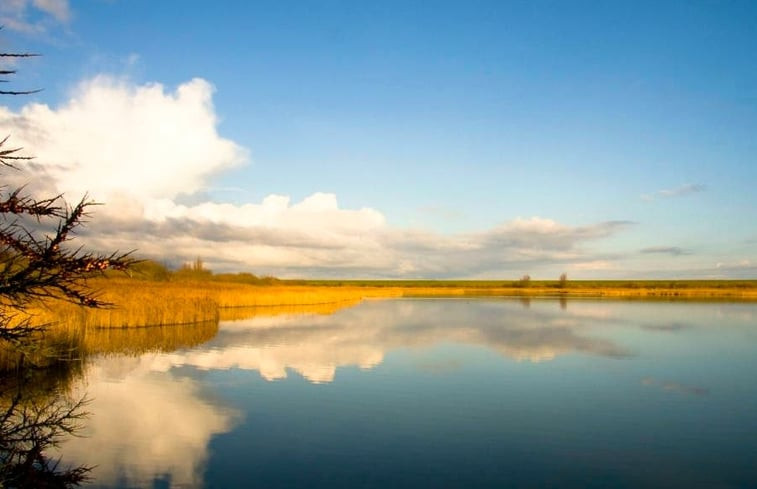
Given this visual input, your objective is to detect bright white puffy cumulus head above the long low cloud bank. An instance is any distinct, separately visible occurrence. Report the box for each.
[0,76,246,202]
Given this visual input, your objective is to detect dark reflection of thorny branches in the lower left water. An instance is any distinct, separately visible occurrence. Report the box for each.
[0,366,90,489]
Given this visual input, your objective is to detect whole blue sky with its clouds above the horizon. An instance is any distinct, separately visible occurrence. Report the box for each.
[0,0,757,279]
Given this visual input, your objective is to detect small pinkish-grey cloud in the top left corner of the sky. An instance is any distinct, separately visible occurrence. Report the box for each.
[0,0,71,34]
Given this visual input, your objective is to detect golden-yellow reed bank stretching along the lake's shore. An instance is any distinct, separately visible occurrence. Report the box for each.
[19,278,757,328]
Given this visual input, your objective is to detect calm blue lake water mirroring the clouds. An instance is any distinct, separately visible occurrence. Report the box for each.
[53,299,757,488]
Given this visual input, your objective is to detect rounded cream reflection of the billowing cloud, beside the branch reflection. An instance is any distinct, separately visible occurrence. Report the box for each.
[62,355,233,487]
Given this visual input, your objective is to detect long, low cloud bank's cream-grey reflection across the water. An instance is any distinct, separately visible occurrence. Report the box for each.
[145,300,629,382]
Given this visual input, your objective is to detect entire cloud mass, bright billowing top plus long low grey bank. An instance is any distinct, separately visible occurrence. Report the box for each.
[0,76,632,277]
